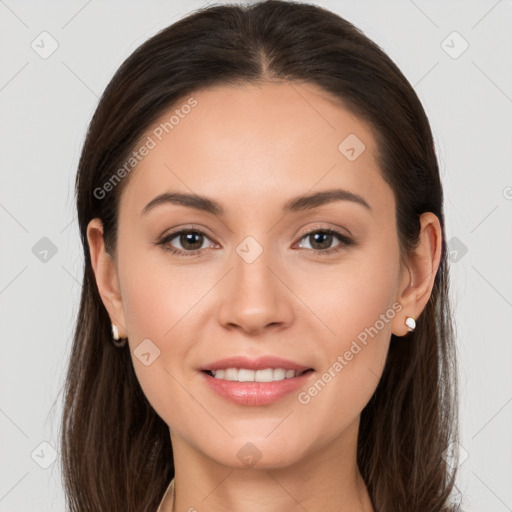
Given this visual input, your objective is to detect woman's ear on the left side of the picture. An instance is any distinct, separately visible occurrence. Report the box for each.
[87,218,128,338]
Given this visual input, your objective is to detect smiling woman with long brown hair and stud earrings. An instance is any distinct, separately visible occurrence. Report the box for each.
[62,0,457,512]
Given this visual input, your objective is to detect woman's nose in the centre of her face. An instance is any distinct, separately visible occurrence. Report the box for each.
[218,241,296,335]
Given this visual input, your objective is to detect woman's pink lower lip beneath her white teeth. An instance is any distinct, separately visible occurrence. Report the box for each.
[201,371,314,405]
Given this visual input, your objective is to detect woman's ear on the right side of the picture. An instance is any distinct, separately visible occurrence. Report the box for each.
[392,212,443,336]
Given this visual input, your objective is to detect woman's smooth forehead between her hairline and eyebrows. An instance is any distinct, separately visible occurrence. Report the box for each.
[121,82,391,220]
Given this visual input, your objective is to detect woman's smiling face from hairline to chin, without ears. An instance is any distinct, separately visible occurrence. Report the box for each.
[96,83,410,467]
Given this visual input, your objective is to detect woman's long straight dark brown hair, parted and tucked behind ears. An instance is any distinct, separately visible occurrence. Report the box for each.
[61,0,458,512]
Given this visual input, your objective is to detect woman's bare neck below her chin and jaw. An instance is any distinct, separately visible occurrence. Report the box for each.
[165,424,373,512]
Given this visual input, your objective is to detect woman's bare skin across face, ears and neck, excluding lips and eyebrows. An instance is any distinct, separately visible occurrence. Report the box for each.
[87,82,442,512]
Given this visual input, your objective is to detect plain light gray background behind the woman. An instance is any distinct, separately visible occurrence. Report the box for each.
[0,0,512,512]
